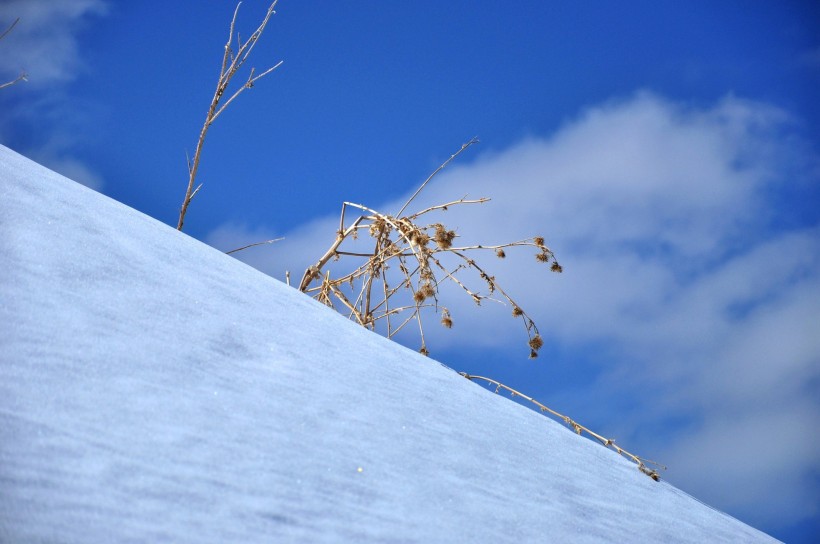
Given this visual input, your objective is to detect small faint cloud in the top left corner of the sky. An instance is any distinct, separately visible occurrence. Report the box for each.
[0,0,106,86]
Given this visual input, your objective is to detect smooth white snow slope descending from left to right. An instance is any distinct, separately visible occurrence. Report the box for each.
[0,146,774,543]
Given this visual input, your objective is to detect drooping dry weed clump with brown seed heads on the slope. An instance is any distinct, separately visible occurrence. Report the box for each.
[299,138,561,358]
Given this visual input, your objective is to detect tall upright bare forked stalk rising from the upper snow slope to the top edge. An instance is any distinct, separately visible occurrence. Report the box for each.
[177,0,282,230]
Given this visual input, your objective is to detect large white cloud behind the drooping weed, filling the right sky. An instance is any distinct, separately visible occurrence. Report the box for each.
[211,93,820,523]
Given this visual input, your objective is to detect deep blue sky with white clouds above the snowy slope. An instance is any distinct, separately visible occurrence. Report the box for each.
[0,0,820,542]
